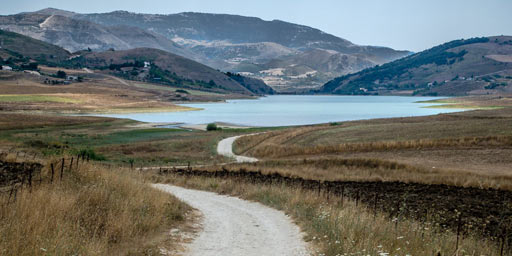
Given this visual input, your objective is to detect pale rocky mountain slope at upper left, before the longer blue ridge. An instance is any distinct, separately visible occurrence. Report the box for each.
[0,10,194,58]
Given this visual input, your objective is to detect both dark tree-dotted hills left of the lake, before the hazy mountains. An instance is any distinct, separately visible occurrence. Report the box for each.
[0,30,274,95]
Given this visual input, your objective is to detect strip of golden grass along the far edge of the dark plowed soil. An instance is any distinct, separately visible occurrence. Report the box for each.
[206,158,512,190]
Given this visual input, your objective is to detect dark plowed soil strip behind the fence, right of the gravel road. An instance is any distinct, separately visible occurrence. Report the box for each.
[162,169,512,247]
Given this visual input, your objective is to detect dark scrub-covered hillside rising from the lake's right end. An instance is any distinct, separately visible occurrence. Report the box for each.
[319,36,512,96]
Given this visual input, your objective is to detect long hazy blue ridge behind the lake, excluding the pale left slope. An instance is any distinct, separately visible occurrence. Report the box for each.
[75,11,409,91]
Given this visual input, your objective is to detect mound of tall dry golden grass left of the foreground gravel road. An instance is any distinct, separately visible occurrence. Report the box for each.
[0,162,187,255]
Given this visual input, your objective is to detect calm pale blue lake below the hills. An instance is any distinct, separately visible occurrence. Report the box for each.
[94,95,461,126]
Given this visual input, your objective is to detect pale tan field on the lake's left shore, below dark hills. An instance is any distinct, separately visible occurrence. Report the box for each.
[0,66,252,113]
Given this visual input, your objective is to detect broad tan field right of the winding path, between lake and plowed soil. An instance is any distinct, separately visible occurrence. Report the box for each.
[235,97,512,190]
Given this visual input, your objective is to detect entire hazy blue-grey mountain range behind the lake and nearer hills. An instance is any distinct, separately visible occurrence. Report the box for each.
[0,9,410,92]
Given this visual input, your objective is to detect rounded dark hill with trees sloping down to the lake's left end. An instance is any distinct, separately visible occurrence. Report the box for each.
[74,48,267,94]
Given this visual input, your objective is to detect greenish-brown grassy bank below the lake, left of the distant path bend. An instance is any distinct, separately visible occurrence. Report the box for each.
[0,114,276,167]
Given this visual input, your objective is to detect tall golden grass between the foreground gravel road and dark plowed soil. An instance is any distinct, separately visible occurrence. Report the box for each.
[155,175,499,255]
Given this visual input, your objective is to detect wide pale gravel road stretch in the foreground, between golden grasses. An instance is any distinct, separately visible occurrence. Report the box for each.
[153,184,310,256]
